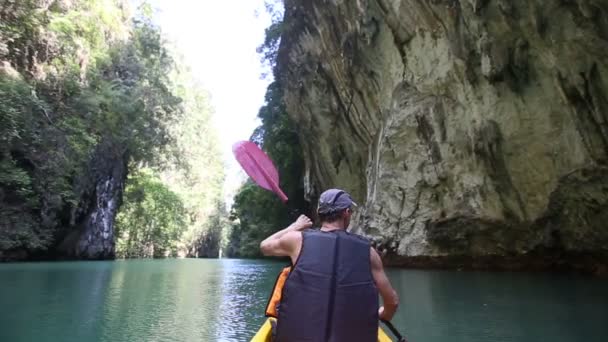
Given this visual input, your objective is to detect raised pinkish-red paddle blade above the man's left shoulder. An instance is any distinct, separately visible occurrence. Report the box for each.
[232,141,287,202]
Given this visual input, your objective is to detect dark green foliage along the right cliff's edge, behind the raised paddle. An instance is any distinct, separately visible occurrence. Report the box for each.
[227,3,308,257]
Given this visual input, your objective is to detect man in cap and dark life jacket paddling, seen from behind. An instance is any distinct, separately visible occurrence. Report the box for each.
[260,189,399,342]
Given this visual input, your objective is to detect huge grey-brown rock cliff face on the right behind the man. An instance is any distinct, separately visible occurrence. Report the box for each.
[278,0,608,272]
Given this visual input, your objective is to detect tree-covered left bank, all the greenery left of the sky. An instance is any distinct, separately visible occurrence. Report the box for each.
[0,0,223,259]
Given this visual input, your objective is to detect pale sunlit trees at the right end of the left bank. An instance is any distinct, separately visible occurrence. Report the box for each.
[153,70,227,257]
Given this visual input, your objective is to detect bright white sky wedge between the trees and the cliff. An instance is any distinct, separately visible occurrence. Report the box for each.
[145,0,271,205]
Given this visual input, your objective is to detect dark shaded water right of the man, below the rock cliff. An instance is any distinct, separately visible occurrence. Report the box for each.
[389,270,608,342]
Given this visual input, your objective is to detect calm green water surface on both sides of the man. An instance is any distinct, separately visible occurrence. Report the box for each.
[0,260,608,342]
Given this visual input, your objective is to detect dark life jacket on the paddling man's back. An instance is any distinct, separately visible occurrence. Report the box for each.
[276,230,379,342]
